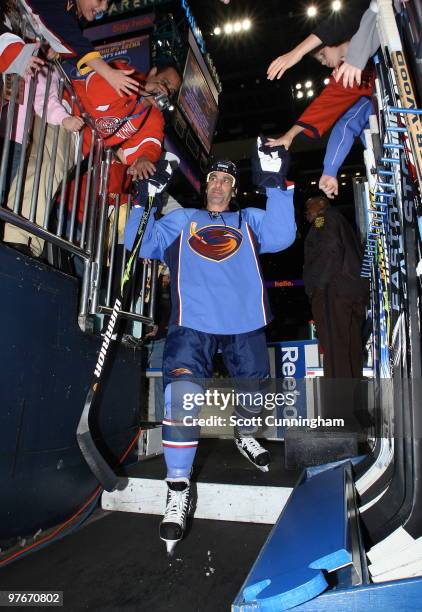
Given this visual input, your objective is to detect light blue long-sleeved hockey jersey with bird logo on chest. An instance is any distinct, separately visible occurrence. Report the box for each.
[125,187,296,334]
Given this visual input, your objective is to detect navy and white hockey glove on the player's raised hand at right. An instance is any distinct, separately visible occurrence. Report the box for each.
[252,136,290,190]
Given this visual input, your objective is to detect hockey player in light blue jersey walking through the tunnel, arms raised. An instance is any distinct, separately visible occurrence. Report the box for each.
[125,139,296,552]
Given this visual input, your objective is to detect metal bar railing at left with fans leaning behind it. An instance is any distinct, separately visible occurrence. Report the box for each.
[0,64,158,336]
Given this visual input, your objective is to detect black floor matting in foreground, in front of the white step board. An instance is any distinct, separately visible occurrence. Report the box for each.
[0,510,272,612]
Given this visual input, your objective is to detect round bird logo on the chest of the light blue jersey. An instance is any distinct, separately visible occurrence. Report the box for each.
[188,222,243,261]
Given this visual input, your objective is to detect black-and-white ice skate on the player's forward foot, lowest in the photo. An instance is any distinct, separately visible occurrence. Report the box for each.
[160,478,190,555]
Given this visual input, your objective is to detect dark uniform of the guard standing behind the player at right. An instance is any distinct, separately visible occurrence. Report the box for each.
[303,206,369,378]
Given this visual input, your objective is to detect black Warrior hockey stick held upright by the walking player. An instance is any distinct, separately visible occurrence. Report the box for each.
[76,153,179,491]
